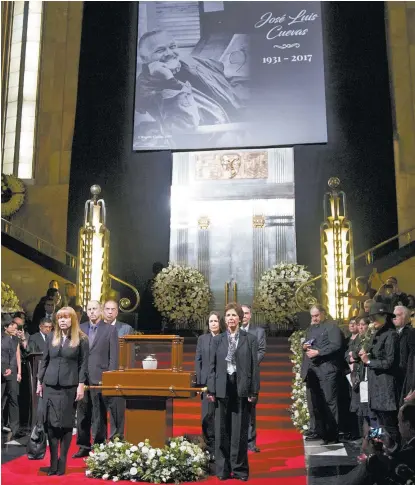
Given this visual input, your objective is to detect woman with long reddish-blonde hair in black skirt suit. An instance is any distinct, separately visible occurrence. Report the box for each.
[36,307,89,475]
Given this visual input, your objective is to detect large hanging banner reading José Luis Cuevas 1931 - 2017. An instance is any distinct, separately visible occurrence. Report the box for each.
[133,1,327,151]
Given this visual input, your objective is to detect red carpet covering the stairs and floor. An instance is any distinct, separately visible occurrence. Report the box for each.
[2,338,306,485]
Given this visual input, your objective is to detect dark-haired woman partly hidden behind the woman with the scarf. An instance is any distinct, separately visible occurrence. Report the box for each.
[195,312,225,461]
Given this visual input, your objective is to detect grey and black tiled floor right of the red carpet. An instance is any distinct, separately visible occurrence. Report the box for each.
[304,441,360,485]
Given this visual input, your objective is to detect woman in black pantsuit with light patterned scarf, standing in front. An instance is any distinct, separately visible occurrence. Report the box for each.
[208,303,259,481]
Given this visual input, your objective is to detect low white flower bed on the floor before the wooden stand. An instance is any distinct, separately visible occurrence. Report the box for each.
[85,436,209,483]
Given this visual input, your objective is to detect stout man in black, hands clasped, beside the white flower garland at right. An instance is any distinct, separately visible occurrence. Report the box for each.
[301,305,344,444]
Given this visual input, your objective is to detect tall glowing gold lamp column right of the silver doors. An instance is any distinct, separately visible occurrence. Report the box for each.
[320,177,354,321]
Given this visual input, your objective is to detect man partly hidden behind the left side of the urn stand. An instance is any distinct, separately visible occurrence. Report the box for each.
[104,300,134,439]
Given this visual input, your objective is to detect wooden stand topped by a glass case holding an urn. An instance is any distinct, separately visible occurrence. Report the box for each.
[100,335,198,447]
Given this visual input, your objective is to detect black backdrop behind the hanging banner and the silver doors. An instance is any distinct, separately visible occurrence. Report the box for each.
[68,2,397,286]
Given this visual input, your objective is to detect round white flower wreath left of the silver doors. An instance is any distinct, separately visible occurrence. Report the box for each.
[153,263,211,322]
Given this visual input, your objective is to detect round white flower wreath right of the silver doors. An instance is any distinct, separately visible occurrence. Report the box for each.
[254,263,314,324]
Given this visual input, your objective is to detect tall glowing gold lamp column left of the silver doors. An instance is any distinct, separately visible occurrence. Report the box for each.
[77,185,110,308]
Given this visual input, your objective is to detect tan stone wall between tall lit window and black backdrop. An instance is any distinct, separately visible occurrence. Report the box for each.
[12,1,83,249]
